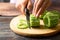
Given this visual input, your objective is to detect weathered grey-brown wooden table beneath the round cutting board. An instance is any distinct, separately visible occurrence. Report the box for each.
[0,16,60,40]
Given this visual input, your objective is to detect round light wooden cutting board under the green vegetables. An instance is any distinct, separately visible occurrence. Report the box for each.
[10,15,60,37]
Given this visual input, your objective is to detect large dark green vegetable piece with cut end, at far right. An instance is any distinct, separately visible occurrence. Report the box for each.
[43,12,59,28]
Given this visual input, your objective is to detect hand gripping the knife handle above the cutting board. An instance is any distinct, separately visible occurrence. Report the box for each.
[16,0,32,14]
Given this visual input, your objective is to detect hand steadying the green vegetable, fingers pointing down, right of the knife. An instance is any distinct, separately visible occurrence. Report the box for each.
[32,0,51,17]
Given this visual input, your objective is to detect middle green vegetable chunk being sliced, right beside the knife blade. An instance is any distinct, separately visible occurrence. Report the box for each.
[30,14,40,28]
